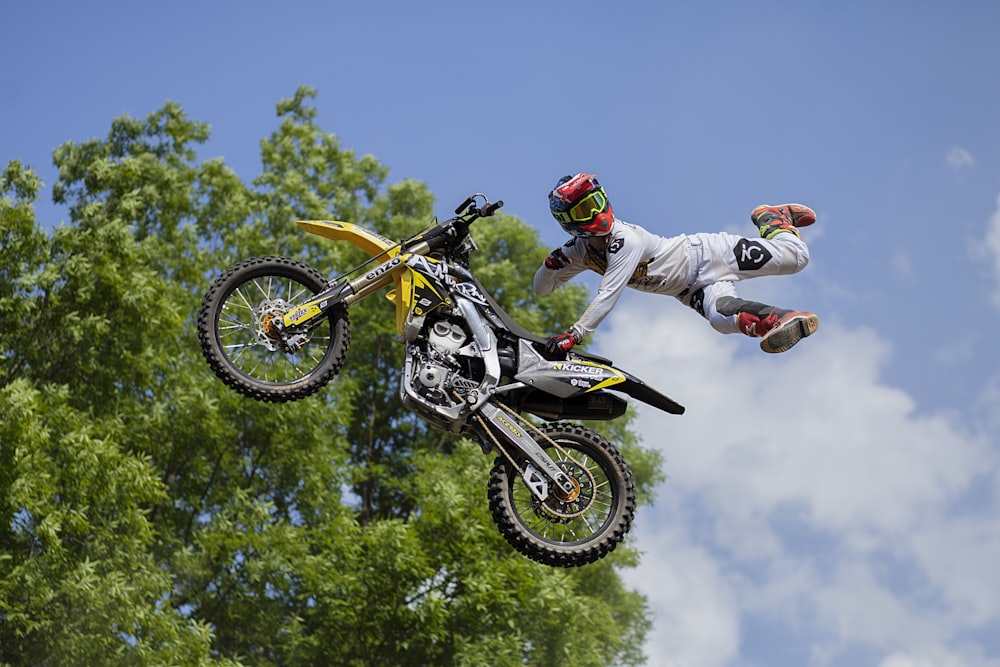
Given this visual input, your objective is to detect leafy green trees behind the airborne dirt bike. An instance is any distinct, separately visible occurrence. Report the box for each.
[0,88,659,667]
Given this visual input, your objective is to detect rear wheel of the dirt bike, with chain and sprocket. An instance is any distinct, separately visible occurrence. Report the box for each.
[489,422,636,567]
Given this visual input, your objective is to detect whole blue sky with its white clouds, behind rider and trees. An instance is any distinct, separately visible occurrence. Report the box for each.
[0,0,1000,667]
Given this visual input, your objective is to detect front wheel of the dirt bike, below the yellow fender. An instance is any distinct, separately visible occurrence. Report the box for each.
[198,257,351,403]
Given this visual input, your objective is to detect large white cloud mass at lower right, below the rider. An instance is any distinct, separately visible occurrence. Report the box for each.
[597,302,1000,667]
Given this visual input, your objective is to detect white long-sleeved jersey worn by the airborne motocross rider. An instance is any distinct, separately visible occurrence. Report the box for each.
[535,219,692,340]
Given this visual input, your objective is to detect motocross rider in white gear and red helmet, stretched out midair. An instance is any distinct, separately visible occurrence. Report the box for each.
[534,173,819,353]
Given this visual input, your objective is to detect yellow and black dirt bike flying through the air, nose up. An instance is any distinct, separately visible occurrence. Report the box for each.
[198,193,684,567]
